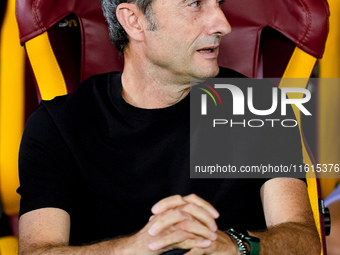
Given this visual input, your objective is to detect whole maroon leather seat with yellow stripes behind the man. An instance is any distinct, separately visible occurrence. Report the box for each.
[17,0,329,252]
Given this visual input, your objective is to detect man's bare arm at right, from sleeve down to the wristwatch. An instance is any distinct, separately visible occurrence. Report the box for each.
[253,178,321,255]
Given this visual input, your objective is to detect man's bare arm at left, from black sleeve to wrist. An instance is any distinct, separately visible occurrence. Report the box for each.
[19,208,133,255]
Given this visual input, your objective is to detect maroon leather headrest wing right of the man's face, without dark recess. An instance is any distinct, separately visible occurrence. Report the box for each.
[219,0,329,76]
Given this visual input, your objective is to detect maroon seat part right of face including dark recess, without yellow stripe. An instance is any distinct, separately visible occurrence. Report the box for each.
[219,0,329,77]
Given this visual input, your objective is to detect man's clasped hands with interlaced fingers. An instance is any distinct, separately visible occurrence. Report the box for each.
[129,194,238,255]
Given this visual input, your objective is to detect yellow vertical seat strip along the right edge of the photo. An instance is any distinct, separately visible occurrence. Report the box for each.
[318,0,340,198]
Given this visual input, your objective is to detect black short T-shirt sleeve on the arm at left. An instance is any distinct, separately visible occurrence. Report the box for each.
[17,105,76,216]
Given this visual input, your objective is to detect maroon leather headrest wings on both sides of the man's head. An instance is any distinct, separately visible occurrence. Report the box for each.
[16,0,329,77]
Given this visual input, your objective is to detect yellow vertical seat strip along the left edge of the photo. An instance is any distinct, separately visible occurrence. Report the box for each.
[0,0,25,216]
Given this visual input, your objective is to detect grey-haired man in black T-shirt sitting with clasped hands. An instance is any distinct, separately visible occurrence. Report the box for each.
[18,0,320,255]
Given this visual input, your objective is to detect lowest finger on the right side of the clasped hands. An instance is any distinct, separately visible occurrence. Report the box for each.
[175,220,217,241]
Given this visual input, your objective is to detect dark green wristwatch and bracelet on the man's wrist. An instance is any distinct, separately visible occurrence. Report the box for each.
[226,228,260,255]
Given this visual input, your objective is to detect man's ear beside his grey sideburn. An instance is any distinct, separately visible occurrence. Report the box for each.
[116,3,146,41]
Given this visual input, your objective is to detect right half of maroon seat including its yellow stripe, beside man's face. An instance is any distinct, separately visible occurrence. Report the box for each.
[219,0,329,254]
